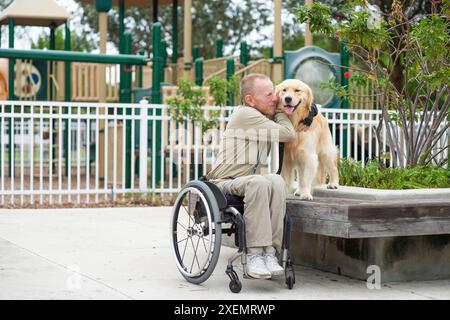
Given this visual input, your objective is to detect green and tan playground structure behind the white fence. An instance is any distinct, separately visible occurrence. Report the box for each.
[0,0,376,195]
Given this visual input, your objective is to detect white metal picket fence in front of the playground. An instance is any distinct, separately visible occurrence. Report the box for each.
[0,101,449,206]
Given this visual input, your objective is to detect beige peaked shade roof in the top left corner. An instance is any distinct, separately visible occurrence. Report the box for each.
[0,0,71,27]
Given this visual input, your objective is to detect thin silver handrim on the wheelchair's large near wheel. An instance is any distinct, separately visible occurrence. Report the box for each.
[171,187,217,278]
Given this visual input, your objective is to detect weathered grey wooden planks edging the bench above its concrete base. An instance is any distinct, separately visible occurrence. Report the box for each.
[287,198,450,238]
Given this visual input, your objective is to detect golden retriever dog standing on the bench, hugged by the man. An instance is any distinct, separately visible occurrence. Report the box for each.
[276,79,339,200]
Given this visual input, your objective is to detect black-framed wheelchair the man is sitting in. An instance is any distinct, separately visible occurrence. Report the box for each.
[171,144,295,293]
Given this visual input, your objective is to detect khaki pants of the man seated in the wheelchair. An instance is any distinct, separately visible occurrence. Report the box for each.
[211,174,287,253]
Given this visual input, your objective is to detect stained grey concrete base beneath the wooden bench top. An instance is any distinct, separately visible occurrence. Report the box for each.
[291,232,450,283]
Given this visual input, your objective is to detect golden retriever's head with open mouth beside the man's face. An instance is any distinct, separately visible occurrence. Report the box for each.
[275,79,313,118]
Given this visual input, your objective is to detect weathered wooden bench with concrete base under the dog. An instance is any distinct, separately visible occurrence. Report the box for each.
[287,189,450,282]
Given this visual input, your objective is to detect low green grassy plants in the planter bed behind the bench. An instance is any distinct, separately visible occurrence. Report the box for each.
[339,159,450,190]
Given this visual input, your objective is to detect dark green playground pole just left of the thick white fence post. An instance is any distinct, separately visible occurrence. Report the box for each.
[120,32,134,188]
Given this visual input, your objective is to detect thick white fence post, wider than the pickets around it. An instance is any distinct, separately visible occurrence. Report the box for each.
[139,99,148,192]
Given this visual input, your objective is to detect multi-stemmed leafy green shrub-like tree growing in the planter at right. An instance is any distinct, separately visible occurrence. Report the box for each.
[298,0,450,167]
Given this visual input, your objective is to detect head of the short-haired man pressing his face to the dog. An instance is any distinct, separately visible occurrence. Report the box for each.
[245,79,278,117]
